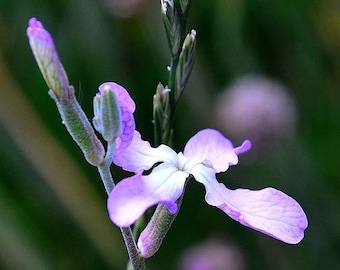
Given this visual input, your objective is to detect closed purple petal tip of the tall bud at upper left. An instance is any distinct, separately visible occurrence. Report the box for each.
[27,18,70,100]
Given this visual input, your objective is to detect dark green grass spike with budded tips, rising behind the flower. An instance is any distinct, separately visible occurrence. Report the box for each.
[153,0,196,148]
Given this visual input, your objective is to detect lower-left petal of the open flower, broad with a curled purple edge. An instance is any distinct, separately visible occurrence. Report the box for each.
[107,163,188,227]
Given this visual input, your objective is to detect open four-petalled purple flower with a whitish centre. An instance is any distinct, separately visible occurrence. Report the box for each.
[108,129,308,244]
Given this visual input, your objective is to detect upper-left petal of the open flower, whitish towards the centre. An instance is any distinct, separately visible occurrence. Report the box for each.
[113,131,178,172]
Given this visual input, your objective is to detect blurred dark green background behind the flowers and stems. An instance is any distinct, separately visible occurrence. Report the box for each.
[0,0,340,270]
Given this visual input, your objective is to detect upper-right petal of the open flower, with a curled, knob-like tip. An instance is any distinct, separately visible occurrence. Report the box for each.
[183,129,251,172]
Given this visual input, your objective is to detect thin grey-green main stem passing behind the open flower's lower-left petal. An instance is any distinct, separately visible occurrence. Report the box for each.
[98,142,146,270]
